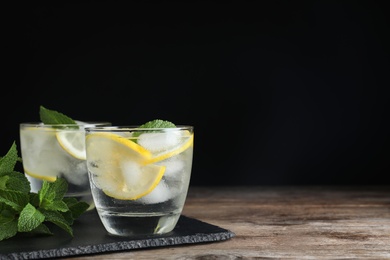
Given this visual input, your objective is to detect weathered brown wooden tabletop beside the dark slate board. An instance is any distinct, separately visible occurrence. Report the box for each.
[72,186,390,259]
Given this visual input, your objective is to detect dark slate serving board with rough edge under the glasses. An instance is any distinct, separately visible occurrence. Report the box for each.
[0,210,235,260]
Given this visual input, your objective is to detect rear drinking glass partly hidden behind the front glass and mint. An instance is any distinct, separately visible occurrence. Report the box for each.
[19,121,111,210]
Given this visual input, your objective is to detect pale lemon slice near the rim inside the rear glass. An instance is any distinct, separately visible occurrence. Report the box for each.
[56,130,86,160]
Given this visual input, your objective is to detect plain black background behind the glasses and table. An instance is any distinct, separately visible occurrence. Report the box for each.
[0,1,390,185]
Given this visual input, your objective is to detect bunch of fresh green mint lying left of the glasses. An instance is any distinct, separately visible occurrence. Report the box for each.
[0,142,89,241]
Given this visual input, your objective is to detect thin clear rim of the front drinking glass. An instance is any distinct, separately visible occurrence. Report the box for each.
[85,125,194,132]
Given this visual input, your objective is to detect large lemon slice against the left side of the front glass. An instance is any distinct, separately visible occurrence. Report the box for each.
[86,133,165,200]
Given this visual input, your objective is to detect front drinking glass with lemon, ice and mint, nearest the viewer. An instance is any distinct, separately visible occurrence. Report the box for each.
[85,126,194,236]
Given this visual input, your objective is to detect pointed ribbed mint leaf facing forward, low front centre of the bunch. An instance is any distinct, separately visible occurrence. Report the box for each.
[18,203,45,232]
